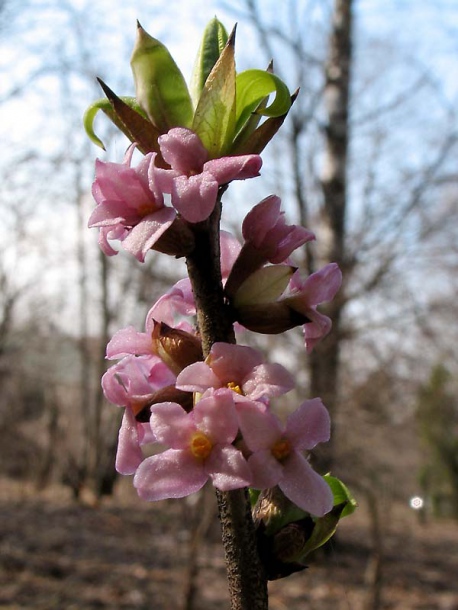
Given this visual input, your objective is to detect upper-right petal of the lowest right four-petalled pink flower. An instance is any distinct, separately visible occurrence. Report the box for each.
[285,398,331,451]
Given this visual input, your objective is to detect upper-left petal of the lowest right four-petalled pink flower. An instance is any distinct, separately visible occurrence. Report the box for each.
[237,401,283,451]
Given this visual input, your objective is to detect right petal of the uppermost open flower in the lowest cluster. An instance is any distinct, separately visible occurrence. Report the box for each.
[243,363,295,400]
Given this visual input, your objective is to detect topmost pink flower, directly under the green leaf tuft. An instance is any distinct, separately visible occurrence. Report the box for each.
[156,127,262,223]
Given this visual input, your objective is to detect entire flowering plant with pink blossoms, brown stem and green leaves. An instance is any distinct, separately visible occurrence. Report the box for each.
[84,18,355,610]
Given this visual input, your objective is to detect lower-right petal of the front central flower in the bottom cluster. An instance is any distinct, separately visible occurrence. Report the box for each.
[204,445,251,491]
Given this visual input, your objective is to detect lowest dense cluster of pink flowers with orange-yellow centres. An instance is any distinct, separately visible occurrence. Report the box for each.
[102,333,332,515]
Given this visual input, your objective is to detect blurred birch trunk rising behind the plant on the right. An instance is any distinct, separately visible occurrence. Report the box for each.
[310,0,352,470]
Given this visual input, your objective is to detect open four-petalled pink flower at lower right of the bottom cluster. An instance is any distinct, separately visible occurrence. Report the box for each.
[238,398,333,516]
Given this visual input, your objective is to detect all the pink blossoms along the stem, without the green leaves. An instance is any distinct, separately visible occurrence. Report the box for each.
[89,128,342,516]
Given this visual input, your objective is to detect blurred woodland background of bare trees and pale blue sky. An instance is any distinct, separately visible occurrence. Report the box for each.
[0,0,458,610]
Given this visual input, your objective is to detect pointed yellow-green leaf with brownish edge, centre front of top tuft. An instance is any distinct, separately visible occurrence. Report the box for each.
[192,29,235,159]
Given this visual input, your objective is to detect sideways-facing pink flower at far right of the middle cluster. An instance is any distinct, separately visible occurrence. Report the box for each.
[280,263,342,352]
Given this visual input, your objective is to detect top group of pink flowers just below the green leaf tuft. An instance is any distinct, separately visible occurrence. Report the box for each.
[89,127,262,262]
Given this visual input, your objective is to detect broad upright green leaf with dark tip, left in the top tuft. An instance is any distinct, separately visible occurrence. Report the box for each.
[130,24,193,133]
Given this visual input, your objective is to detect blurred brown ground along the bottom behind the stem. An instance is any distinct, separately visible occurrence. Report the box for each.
[0,481,458,610]
